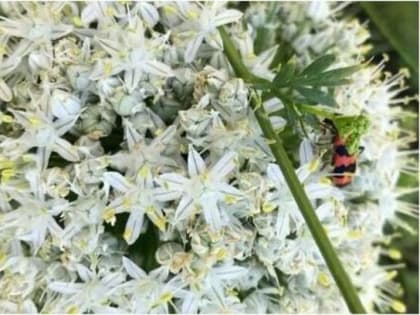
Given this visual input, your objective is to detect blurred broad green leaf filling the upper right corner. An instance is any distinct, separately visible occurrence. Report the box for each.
[360,1,419,85]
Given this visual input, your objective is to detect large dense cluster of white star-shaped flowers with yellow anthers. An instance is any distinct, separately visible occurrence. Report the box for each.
[0,1,415,313]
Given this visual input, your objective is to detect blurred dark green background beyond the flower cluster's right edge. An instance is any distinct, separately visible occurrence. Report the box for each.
[352,2,419,314]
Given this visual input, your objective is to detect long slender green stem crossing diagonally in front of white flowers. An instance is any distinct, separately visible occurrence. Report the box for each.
[219,27,366,313]
